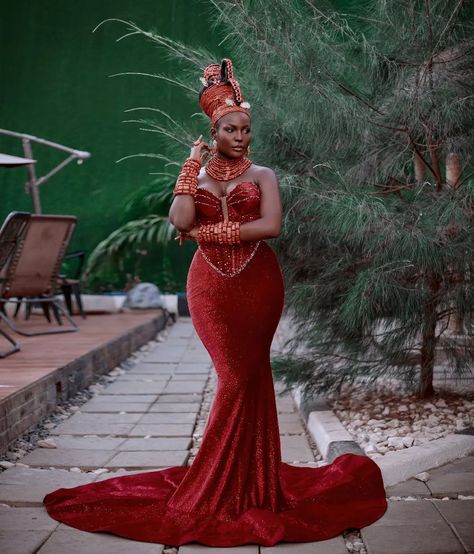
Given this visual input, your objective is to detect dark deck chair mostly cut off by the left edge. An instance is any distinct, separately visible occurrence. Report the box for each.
[0,212,30,358]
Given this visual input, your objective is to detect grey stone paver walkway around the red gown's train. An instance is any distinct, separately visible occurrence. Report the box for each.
[0,318,474,554]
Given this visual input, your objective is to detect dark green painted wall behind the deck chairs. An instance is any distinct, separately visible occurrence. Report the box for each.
[0,0,220,292]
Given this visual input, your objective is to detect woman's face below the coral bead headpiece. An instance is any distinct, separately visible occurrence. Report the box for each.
[212,112,252,159]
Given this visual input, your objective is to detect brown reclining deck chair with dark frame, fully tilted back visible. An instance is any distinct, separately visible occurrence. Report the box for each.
[0,214,78,344]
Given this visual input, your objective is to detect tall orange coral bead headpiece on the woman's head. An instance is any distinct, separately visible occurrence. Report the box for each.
[199,58,250,125]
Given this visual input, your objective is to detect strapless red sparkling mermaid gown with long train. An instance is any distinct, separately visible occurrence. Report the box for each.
[44,182,387,546]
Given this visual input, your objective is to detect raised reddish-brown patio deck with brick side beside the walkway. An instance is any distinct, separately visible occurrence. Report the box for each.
[0,309,165,452]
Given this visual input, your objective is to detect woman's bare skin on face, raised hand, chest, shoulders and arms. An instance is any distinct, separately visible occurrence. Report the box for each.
[168,112,282,241]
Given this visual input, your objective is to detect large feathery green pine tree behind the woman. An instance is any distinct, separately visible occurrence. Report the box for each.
[98,0,474,397]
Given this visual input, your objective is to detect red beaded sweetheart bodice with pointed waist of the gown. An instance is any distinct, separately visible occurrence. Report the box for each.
[194,181,261,277]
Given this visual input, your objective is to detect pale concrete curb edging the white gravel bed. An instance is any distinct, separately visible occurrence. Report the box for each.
[292,387,474,486]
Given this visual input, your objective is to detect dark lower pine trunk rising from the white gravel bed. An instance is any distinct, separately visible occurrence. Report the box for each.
[418,278,440,398]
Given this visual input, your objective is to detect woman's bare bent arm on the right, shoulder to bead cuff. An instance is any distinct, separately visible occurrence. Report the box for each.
[240,167,282,240]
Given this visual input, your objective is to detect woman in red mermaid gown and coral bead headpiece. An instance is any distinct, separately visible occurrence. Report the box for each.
[45,59,387,546]
